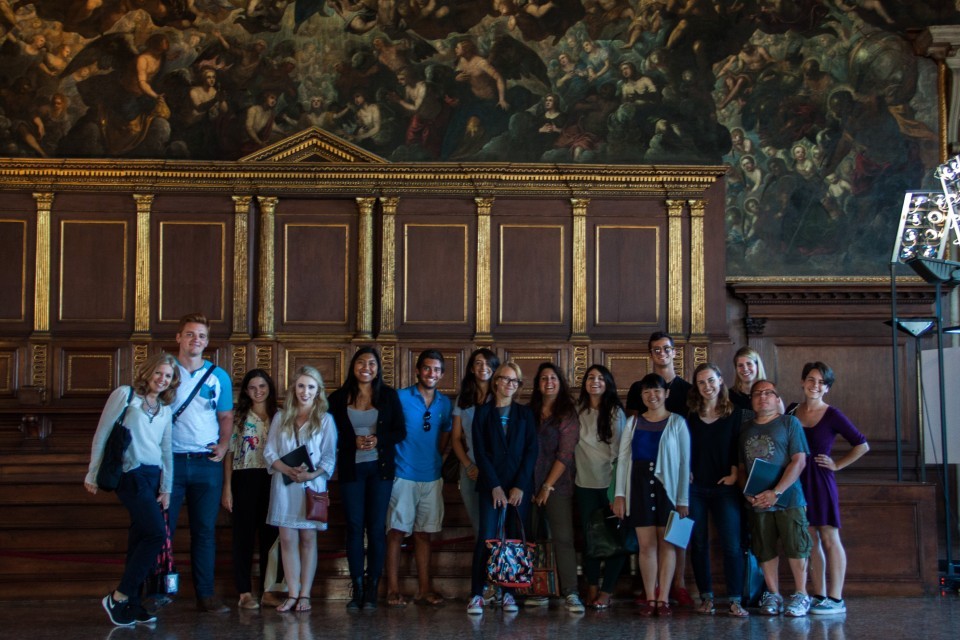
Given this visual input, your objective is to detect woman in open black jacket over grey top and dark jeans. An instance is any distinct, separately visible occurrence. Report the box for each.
[330,346,407,610]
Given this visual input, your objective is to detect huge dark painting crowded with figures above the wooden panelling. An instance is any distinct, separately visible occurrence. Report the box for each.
[0,0,960,276]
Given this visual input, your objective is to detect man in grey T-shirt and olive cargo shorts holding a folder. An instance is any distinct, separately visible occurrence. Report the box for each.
[738,380,813,618]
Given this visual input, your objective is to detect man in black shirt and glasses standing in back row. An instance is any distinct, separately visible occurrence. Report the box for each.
[627,331,693,607]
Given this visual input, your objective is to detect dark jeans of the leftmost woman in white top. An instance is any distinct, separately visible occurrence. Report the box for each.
[117,465,167,604]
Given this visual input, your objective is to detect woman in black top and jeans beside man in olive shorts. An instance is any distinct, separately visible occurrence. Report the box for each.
[687,362,749,618]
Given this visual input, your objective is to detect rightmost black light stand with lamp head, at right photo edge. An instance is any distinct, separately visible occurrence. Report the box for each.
[906,258,960,588]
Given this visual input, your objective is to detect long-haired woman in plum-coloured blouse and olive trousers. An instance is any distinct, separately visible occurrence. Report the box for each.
[526,362,584,613]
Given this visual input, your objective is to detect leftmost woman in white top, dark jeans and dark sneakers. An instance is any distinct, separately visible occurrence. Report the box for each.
[83,352,180,627]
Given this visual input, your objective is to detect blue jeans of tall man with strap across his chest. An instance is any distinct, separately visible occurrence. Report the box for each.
[170,453,223,598]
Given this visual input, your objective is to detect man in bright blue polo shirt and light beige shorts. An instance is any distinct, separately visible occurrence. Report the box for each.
[385,349,453,607]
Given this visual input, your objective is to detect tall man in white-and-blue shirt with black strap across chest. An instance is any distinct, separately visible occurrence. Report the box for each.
[170,313,233,613]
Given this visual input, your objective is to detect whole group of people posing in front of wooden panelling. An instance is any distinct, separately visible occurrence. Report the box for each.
[84,314,869,626]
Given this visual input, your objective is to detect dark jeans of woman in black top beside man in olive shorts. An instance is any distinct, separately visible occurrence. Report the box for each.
[690,484,743,601]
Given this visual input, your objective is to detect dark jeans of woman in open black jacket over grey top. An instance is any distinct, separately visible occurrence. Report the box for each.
[340,460,393,580]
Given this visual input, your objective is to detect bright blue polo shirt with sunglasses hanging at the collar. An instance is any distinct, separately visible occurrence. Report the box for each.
[397,384,453,482]
